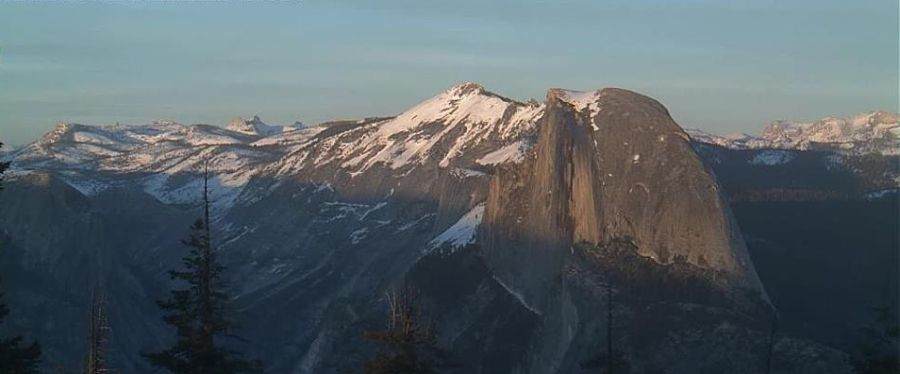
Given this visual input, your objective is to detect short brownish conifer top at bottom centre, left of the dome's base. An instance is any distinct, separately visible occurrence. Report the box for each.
[366,290,458,374]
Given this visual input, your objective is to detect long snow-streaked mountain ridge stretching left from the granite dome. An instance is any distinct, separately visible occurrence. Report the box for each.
[9,83,543,212]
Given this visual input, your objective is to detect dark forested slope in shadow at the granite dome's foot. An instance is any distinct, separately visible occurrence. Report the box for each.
[405,241,849,373]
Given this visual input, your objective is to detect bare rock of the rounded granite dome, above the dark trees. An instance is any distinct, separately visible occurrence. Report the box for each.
[480,89,763,308]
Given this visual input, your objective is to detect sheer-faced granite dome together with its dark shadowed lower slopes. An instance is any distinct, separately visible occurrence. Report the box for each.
[407,89,846,373]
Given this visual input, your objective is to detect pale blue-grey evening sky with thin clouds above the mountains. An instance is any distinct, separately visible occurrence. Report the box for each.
[0,0,900,145]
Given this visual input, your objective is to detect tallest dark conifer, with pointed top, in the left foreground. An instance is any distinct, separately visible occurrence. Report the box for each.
[144,170,261,374]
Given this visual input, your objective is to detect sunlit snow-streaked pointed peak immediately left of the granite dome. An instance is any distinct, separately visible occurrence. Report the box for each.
[268,83,543,177]
